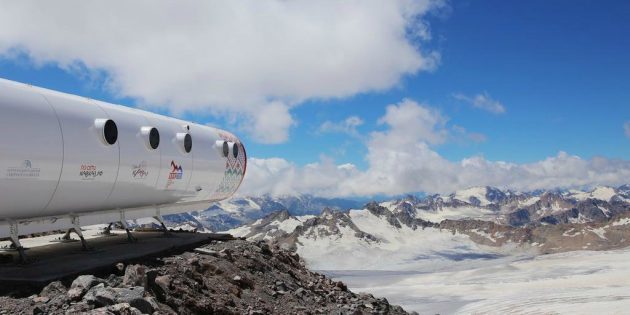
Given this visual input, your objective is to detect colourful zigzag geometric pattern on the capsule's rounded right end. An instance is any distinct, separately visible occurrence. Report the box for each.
[210,132,247,200]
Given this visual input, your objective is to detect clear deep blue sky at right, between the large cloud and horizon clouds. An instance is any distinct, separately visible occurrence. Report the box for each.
[256,1,630,168]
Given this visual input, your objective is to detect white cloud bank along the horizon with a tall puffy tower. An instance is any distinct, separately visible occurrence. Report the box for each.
[241,100,630,196]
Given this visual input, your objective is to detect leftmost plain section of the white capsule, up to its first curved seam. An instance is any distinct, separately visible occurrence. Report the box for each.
[0,84,63,218]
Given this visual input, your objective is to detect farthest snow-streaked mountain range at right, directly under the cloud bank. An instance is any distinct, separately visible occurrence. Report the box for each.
[381,185,630,226]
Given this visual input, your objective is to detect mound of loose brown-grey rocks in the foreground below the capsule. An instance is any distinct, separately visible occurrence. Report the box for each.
[0,240,407,314]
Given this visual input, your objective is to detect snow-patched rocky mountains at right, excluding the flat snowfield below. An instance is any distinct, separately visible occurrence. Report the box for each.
[229,186,630,269]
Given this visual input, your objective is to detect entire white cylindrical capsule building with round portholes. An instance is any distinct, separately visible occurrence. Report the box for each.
[0,79,247,240]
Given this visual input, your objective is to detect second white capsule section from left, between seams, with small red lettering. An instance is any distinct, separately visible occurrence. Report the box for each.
[42,89,119,216]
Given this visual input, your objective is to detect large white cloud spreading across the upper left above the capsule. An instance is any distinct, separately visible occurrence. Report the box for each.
[0,0,443,143]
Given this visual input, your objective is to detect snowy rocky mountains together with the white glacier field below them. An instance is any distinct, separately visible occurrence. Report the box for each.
[229,185,630,314]
